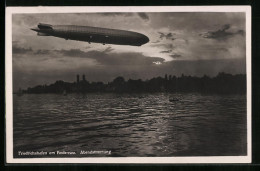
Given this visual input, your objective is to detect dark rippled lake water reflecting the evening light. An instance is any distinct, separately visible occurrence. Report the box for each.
[13,93,247,157]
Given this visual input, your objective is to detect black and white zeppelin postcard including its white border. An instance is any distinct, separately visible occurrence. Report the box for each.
[5,6,251,163]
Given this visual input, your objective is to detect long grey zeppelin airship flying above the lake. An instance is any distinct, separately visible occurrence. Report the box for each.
[31,23,149,46]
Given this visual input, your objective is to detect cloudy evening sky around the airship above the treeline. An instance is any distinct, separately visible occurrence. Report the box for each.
[12,12,246,90]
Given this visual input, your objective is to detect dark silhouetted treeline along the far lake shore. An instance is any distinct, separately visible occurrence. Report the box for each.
[25,72,246,94]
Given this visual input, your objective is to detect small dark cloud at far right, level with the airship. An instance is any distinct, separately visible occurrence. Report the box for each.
[199,24,244,40]
